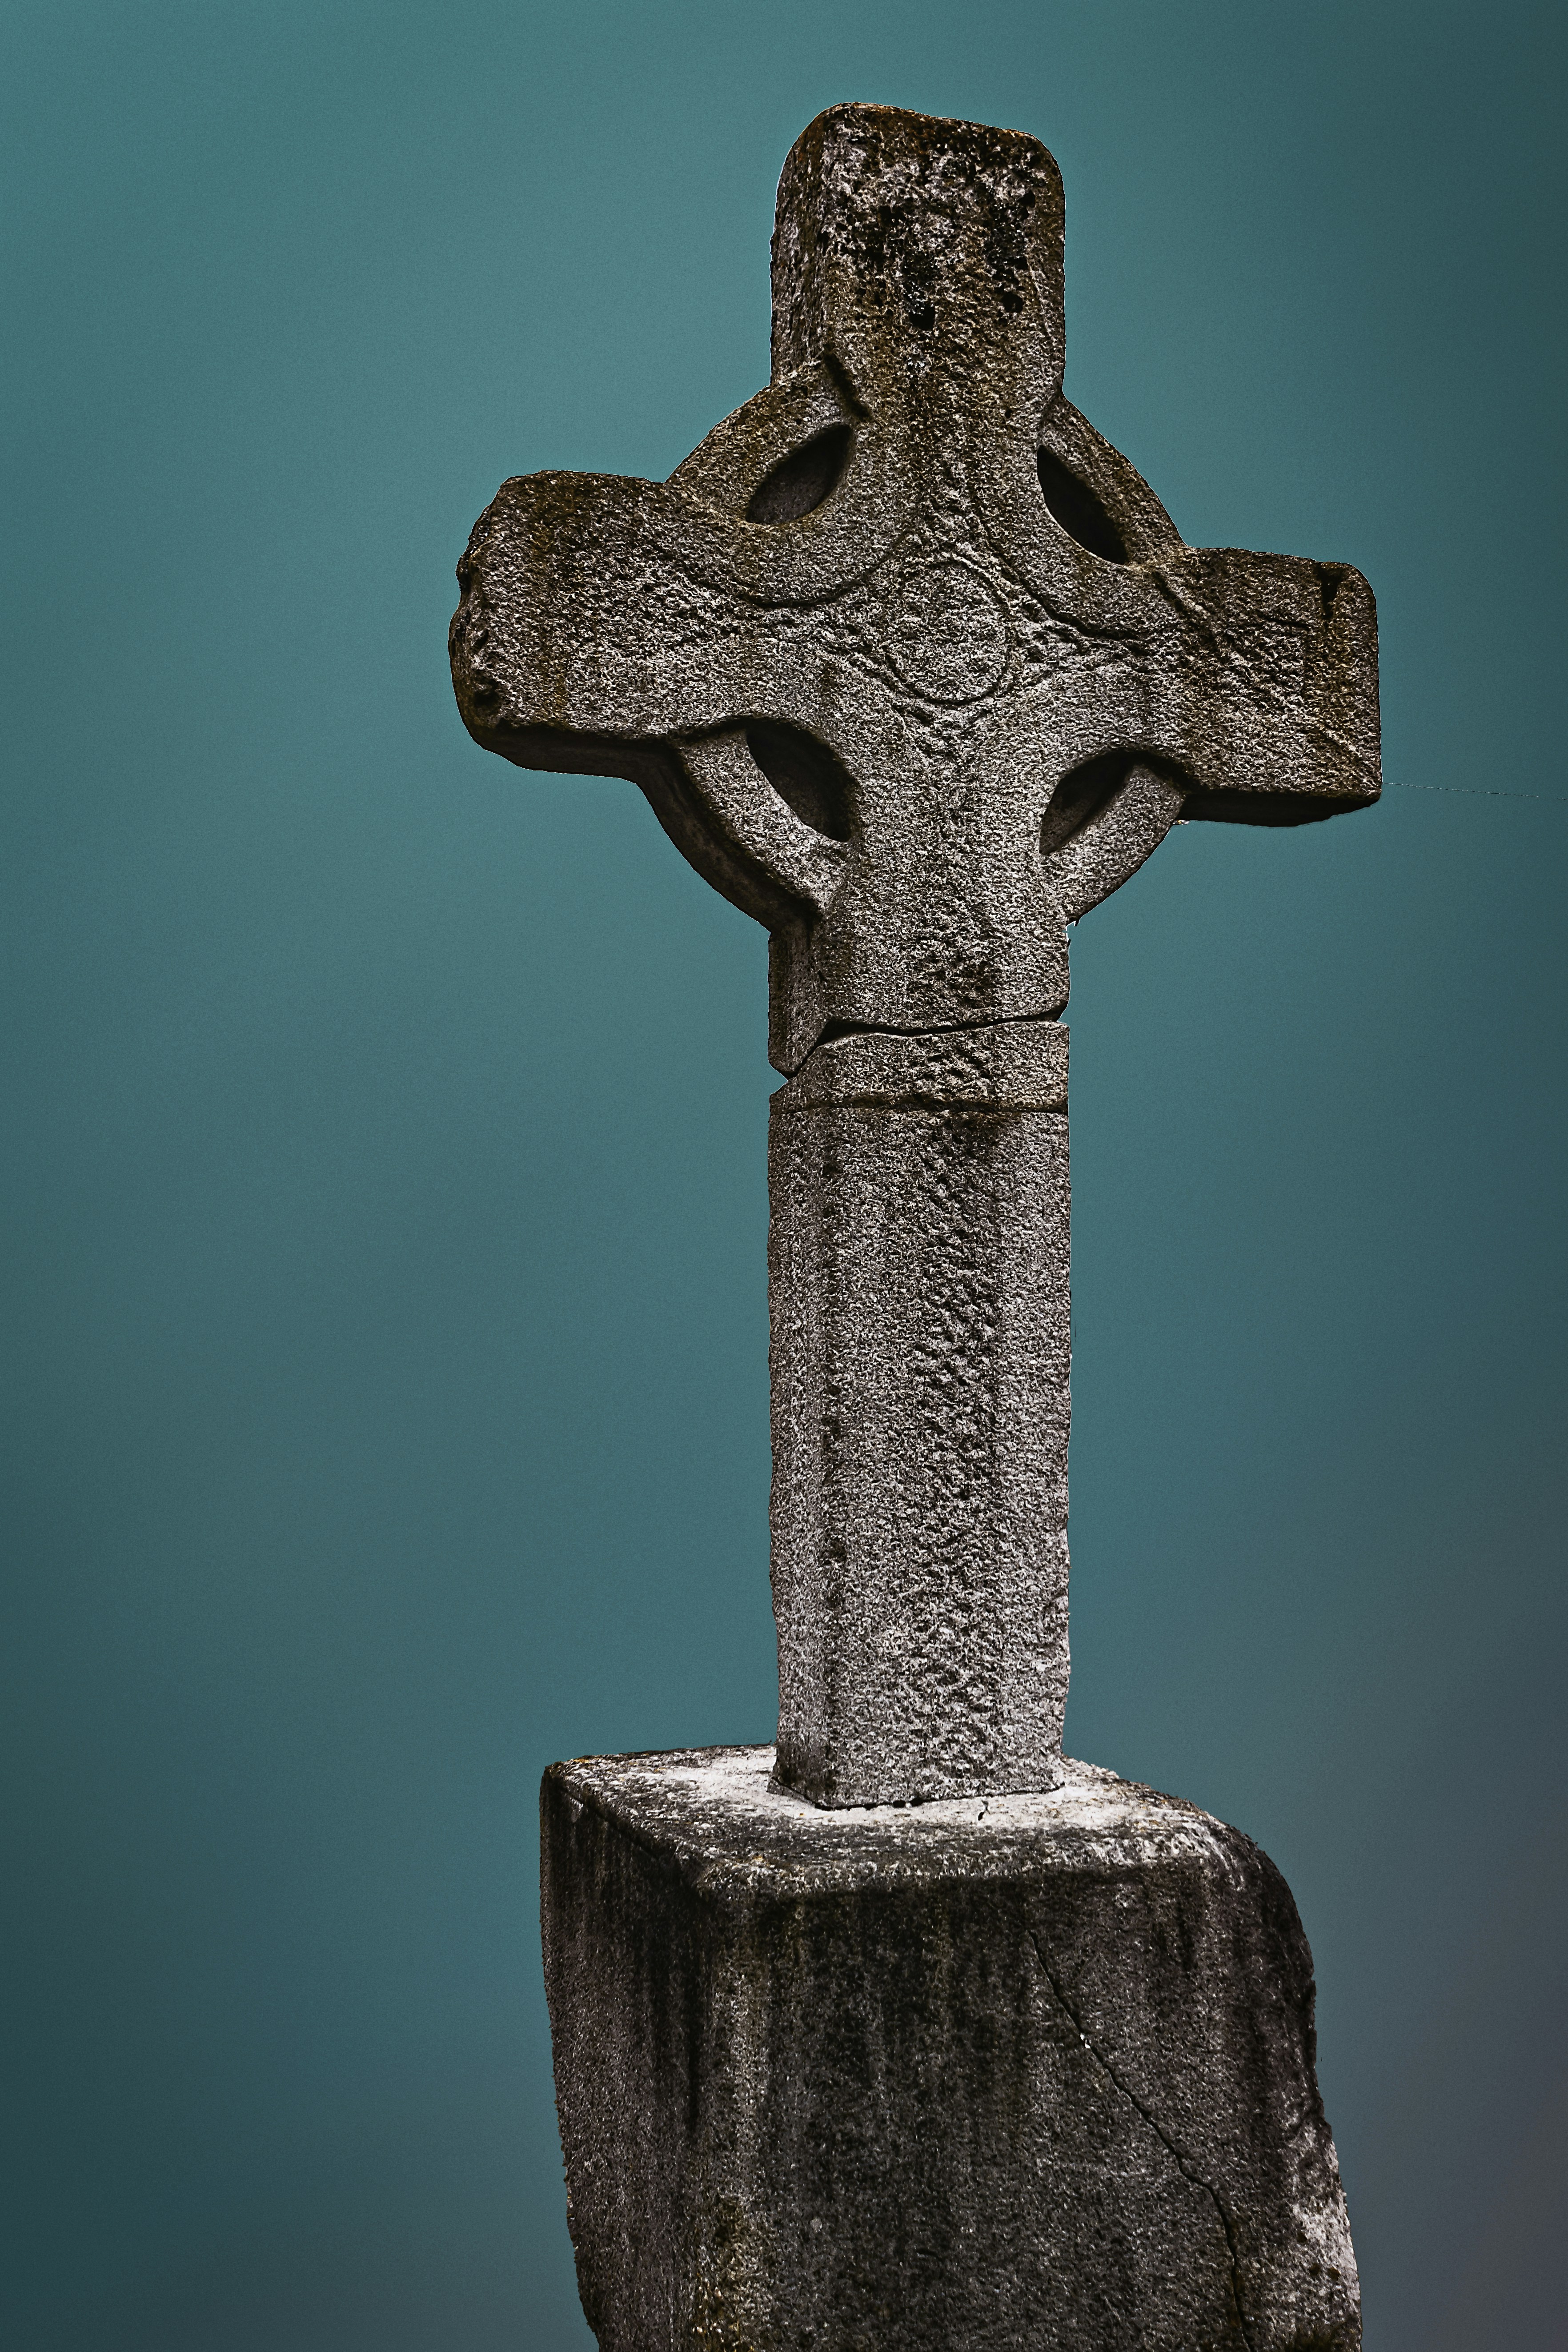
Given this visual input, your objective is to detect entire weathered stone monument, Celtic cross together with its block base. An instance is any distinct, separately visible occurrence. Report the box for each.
[451,106,1380,2352]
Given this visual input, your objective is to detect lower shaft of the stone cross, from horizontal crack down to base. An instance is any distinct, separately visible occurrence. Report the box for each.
[769,1021,1070,1804]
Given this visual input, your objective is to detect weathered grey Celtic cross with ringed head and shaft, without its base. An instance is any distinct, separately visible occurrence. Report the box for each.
[451,106,1380,1806]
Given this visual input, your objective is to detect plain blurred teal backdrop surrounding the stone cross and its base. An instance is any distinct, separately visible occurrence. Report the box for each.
[0,0,1568,2352]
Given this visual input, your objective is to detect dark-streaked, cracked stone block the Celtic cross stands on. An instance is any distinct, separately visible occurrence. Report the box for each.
[543,1747,1361,2352]
